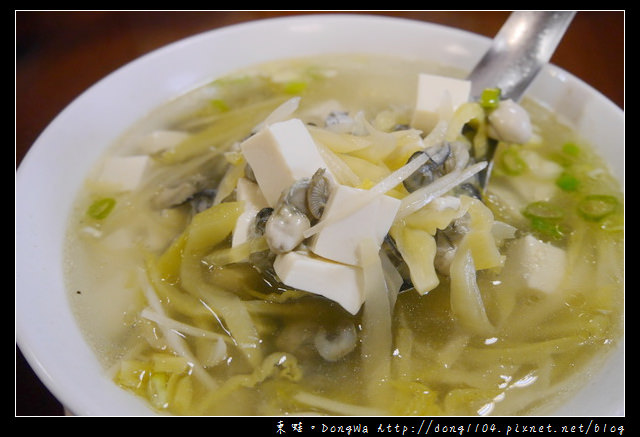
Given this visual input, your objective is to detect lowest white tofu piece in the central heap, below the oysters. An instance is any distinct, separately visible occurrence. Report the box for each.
[273,252,364,314]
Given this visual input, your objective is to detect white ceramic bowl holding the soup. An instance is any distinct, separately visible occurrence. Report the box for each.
[15,15,624,416]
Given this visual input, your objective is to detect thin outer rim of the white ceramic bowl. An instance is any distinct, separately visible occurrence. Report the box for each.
[15,13,624,415]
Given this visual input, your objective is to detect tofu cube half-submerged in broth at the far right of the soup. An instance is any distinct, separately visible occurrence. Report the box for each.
[503,235,566,294]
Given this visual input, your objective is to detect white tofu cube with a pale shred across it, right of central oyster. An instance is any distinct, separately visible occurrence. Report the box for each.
[309,185,400,265]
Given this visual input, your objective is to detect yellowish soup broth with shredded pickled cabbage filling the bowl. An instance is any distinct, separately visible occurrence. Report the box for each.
[66,52,624,415]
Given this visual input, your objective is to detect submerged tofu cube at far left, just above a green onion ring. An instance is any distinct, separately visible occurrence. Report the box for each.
[96,155,150,191]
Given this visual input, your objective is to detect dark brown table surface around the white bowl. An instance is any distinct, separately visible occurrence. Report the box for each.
[15,11,625,416]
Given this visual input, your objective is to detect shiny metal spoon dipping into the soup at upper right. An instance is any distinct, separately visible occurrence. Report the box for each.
[468,11,575,191]
